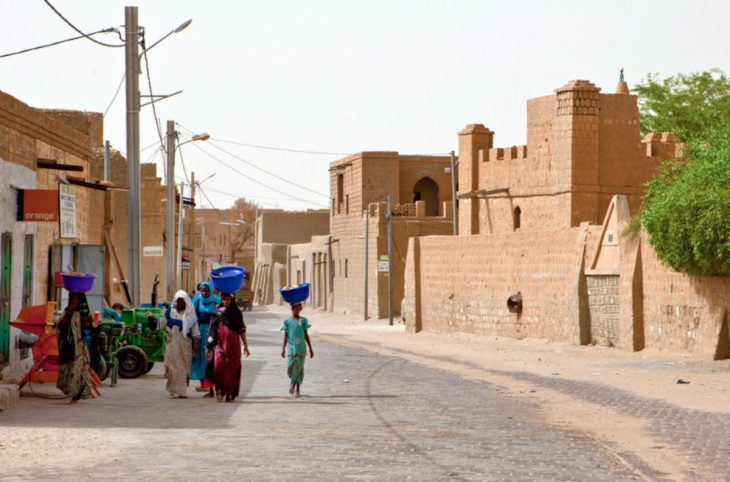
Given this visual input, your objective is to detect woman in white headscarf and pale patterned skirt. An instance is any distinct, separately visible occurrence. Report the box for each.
[165,290,200,398]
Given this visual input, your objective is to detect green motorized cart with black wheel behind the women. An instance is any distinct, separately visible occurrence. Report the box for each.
[117,306,166,378]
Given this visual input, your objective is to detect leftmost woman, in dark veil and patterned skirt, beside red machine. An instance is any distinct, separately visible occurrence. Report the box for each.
[56,293,94,403]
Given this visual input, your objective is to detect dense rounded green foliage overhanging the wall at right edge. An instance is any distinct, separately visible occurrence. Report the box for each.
[642,128,730,276]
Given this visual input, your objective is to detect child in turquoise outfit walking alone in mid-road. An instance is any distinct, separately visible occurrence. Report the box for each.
[281,303,314,398]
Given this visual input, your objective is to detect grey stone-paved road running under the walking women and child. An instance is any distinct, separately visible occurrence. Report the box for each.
[0,312,660,481]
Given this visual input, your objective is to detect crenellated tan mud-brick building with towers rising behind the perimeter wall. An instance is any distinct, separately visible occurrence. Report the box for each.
[459,80,681,235]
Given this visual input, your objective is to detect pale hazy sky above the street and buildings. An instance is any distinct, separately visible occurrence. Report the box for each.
[0,0,730,209]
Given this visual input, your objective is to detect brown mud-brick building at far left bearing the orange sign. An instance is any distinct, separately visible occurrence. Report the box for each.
[0,92,103,375]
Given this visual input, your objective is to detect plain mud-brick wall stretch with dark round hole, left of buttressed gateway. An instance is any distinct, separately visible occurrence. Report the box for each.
[403,228,585,342]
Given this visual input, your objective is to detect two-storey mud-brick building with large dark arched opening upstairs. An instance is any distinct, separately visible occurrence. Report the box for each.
[329,152,453,317]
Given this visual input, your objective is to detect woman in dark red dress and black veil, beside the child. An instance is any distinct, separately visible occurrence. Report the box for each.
[208,293,251,402]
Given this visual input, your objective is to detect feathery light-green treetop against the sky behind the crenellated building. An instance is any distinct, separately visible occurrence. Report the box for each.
[634,69,730,142]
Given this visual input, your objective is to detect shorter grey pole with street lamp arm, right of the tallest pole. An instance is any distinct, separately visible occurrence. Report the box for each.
[165,121,210,301]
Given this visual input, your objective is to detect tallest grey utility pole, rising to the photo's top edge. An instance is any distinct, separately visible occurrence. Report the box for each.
[124,7,142,306]
